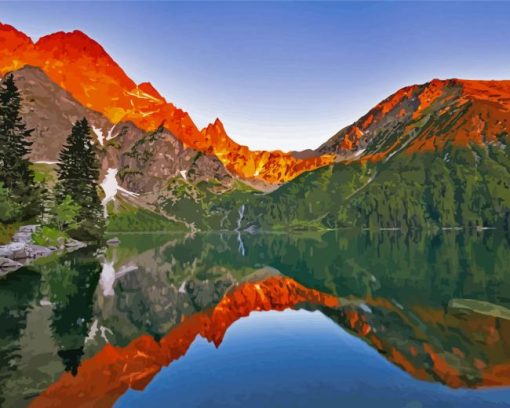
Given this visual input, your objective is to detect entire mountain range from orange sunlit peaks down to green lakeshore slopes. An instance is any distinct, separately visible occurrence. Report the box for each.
[0,25,510,230]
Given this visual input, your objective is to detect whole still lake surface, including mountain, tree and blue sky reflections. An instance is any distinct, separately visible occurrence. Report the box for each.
[0,231,510,407]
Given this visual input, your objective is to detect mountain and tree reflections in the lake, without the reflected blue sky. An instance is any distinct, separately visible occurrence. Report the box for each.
[0,231,510,406]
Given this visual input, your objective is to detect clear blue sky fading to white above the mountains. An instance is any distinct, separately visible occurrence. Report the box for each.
[0,1,510,150]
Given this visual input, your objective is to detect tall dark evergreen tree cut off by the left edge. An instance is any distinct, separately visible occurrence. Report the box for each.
[0,74,41,218]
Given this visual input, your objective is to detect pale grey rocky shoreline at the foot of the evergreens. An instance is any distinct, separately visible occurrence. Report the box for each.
[0,225,87,277]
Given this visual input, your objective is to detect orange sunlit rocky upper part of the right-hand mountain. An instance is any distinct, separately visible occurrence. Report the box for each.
[319,79,510,161]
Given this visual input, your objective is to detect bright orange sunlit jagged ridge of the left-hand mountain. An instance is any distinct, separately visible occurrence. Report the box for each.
[0,24,333,183]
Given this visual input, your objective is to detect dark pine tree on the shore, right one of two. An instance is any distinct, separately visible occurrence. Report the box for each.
[56,118,104,239]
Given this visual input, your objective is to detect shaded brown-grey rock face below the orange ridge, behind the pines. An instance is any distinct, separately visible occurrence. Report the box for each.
[3,65,232,194]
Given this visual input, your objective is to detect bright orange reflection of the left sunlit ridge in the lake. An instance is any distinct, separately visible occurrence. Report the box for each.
[31,276,339,407]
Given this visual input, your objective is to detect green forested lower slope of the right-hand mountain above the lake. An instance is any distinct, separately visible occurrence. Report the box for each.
[235,141,510,230]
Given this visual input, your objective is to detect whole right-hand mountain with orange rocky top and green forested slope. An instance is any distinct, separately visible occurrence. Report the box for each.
[159,79,510,229]
